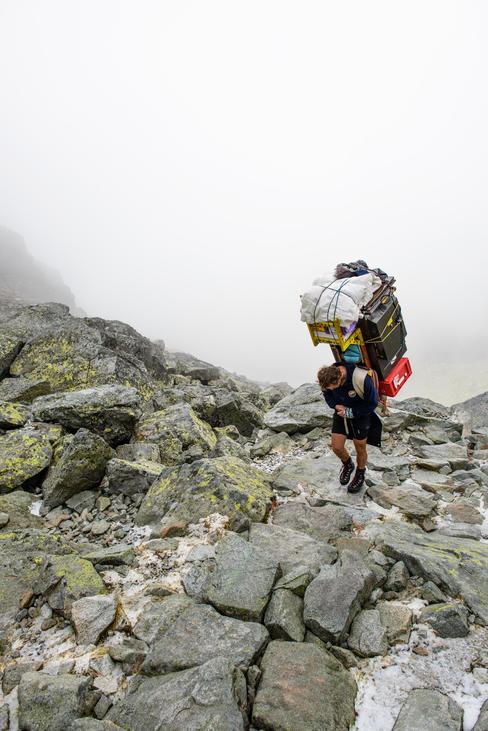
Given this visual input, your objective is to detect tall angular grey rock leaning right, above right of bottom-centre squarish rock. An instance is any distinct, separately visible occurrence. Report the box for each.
[303,551,375,644]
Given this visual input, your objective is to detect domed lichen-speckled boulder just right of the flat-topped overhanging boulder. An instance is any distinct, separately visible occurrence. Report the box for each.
[135,403,217,465]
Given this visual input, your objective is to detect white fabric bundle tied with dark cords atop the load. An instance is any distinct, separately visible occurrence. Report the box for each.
[300,271,382,328]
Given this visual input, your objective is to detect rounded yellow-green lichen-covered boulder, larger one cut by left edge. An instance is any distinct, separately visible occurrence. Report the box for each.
[0,428,52,493]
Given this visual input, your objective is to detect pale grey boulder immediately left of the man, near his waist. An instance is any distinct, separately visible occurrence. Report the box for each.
[264,383,332,434]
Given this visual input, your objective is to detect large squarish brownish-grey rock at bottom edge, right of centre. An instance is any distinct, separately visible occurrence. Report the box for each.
[252,640,357,731]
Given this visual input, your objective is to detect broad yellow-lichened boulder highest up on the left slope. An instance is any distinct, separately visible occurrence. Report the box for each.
[10,318,152,398]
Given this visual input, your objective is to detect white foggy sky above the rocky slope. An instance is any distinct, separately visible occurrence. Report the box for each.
[0,0,488,403]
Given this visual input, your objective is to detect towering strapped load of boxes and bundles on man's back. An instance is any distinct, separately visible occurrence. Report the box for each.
[301,260,412,396]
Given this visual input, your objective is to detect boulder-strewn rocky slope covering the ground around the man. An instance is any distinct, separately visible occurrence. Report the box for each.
[0,304,488,731]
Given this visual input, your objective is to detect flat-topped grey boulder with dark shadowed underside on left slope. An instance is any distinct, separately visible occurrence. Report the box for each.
[32,384,141,446]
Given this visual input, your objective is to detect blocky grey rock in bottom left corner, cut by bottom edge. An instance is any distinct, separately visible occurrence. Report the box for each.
[19,673,91,731]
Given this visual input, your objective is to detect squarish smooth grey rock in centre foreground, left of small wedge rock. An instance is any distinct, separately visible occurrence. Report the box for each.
[203,534,279,622]
